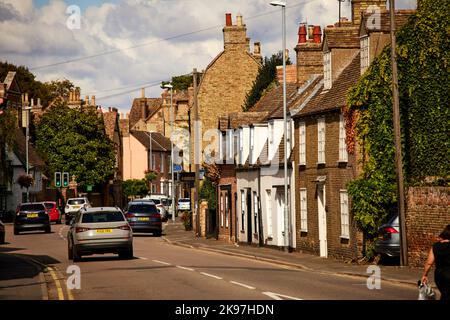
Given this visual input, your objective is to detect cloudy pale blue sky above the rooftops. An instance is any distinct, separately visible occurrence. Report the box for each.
[0,0,416,112]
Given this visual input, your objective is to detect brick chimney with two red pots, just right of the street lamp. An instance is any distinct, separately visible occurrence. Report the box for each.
[296,24,323,87]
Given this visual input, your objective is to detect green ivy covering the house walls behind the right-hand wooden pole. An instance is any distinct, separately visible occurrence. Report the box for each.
[347,0,450,238]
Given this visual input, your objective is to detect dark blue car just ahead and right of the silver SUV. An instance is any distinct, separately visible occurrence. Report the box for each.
[125,200,162,237]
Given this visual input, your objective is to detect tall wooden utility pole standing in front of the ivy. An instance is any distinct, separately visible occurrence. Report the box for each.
[389,0,408,266]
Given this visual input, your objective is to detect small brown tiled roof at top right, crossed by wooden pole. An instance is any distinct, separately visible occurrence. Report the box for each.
[360,10,416,35]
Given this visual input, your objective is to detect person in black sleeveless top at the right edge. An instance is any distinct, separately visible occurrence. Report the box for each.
[421,224,450,301]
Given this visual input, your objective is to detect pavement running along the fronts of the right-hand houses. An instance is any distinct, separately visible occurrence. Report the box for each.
[163,220,428,287]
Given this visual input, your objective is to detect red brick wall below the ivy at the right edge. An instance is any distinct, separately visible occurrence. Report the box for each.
[406,187,450,267]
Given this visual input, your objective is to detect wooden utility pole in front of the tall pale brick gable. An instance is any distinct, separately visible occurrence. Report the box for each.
[192,68,202,236]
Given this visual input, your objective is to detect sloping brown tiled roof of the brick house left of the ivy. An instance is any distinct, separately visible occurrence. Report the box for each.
[297,53,361,116]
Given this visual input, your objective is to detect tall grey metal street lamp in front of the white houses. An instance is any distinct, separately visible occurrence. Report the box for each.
[270,1,290,250]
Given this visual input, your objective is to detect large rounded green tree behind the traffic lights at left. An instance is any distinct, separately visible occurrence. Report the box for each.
[36,105,115,185]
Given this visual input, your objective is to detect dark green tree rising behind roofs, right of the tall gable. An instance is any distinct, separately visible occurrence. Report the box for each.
[242,52,291,111]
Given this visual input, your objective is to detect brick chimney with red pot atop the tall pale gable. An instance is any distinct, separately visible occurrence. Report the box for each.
[223,13,250,51]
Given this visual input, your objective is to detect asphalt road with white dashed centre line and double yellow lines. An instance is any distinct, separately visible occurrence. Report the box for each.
[0,224,417,300]
